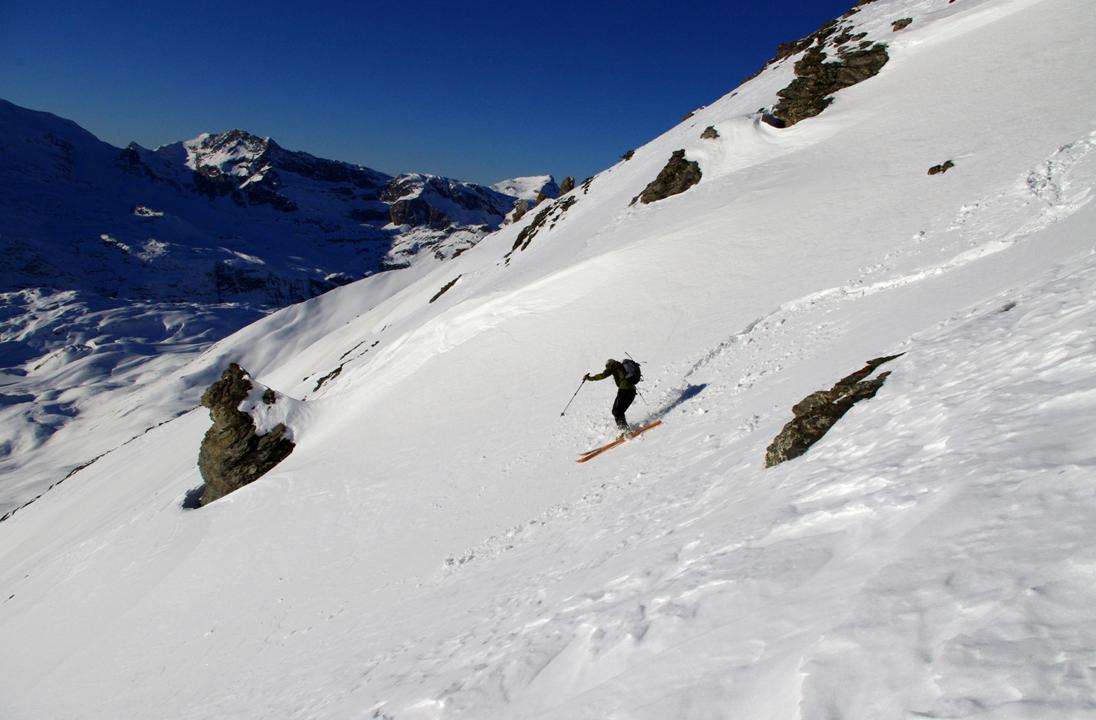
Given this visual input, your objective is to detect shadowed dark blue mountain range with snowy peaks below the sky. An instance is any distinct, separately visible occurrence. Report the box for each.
[0,101,550,308]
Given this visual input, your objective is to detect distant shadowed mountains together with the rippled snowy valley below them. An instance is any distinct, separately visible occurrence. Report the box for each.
[0,101,528,517]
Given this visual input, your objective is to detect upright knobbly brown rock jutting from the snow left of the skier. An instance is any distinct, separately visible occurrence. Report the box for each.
[198,363,294,505]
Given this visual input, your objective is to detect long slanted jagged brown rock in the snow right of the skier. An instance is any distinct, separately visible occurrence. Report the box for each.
[765,355,901,468]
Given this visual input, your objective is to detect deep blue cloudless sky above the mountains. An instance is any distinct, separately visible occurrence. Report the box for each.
[0,0,854,183]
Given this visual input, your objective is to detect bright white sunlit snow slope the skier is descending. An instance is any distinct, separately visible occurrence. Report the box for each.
[0,0,1096,720]
